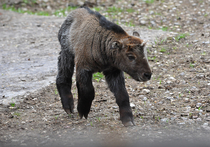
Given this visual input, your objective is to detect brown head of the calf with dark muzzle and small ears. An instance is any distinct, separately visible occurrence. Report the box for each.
[110,32,152,82]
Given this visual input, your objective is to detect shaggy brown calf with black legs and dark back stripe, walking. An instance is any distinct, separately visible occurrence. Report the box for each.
[56,7,152,126]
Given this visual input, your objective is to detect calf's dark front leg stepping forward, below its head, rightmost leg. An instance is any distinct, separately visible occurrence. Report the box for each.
[104,69,134,126]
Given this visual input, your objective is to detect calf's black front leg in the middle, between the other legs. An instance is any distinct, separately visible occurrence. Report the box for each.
[76,70,95,119]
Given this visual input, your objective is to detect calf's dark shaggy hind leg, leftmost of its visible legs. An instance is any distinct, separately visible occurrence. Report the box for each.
[56,50,74,114]
